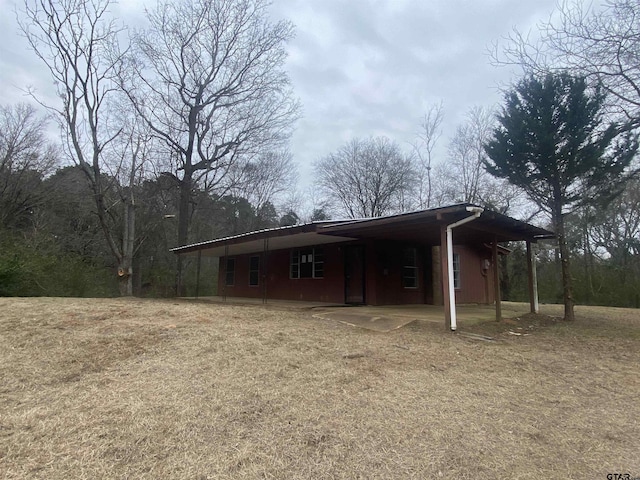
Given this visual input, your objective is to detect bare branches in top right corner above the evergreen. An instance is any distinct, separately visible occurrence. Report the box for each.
[493,0,640,127]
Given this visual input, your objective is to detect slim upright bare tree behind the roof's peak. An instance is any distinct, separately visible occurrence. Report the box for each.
[413,102,444,208]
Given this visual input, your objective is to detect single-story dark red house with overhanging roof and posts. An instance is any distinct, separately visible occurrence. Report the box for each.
[172,204,554,329]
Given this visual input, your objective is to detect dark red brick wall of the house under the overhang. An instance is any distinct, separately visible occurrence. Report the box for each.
[218,241,494,305]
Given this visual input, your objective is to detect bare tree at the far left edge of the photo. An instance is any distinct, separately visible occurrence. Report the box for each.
[0,103,57,226]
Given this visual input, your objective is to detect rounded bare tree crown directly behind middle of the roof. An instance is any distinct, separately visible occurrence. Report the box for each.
[315,137,415,218]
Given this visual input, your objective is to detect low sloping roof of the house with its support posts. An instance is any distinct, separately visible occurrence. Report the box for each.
[173,204,554,330]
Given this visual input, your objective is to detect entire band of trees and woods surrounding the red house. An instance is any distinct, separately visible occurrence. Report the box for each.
[0,0,640,316]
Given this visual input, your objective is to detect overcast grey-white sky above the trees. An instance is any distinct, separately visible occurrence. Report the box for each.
[0,0,555,191]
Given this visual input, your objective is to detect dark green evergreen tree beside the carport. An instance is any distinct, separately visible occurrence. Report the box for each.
[485,73,638,320]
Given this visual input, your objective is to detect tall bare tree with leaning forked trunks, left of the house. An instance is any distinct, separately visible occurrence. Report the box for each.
[20,0,145,295]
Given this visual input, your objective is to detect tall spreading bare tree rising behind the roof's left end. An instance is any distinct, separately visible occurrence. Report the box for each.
[123,0,298,289]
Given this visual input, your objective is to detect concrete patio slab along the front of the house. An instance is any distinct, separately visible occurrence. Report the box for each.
[185,297,527,332]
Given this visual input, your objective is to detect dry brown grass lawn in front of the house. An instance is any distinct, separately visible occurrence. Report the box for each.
[0,299,640,479]
